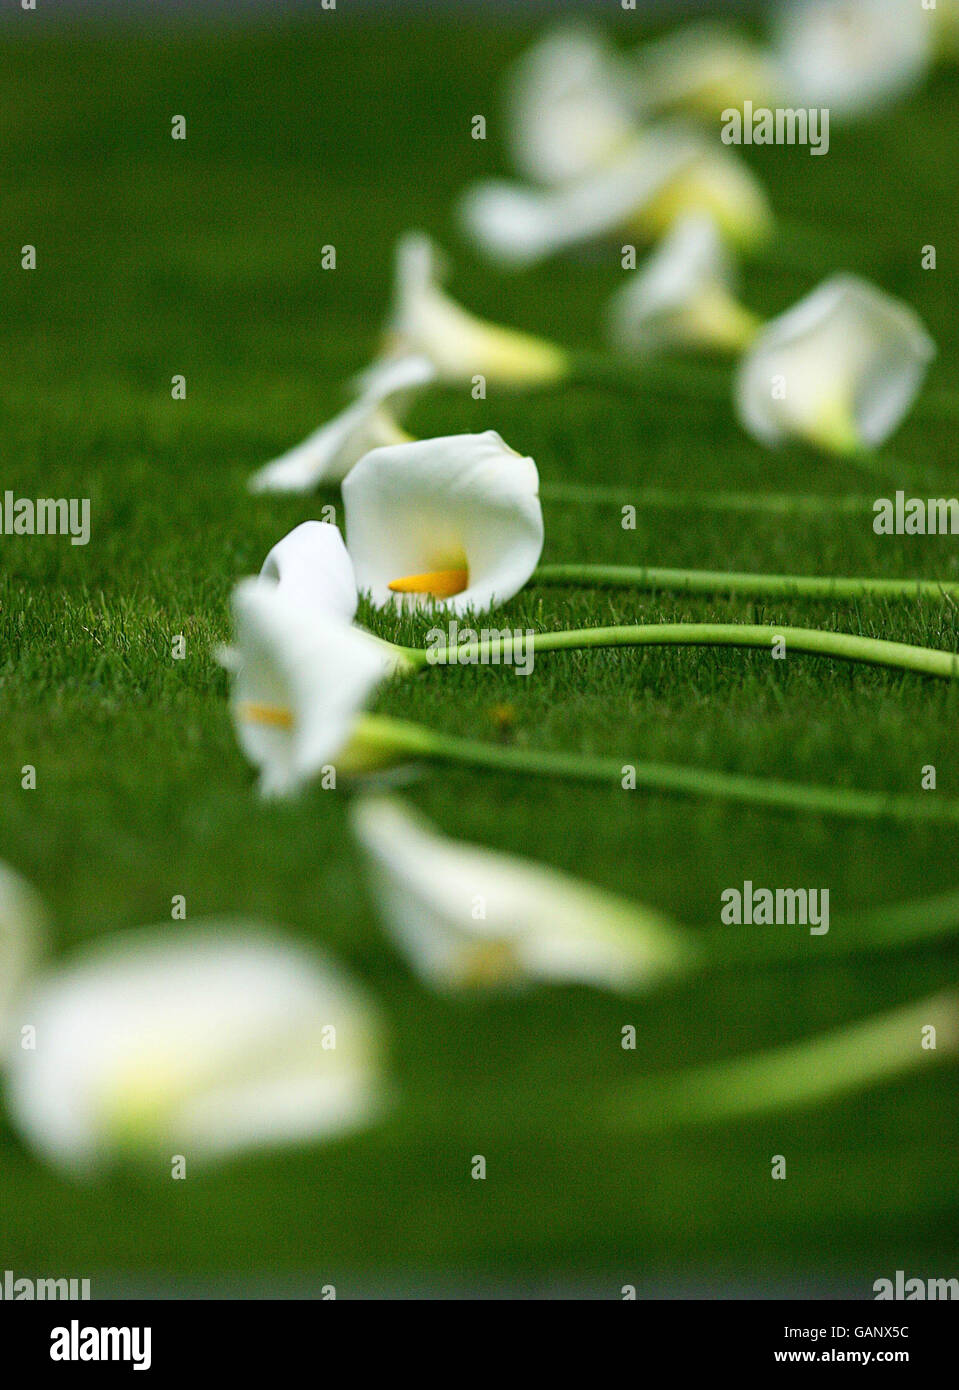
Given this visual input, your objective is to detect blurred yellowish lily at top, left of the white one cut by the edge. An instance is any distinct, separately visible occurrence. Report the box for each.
[631,19,781,120]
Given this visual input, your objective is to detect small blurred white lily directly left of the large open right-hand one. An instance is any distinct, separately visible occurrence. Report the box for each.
[609,214,759,352]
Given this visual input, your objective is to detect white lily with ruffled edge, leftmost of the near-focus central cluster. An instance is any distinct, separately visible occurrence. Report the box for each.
[221,580,399,796]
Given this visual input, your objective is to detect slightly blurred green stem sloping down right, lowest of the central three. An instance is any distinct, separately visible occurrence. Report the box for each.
[356,714,959,826]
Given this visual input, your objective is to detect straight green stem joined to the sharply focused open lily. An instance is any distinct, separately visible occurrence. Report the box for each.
[532,564,959,599]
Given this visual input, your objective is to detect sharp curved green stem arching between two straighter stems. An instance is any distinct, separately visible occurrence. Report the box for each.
[404,623,959,678]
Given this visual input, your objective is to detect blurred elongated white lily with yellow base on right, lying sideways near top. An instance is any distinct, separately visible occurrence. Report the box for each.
[459,129,770,267]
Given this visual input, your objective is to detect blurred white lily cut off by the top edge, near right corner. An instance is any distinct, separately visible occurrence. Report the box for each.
[776,0,934,115]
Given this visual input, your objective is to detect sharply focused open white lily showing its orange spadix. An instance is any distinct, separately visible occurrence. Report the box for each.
[343,430,543,613]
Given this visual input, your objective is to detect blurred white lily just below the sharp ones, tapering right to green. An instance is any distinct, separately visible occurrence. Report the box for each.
[352,796,692,991]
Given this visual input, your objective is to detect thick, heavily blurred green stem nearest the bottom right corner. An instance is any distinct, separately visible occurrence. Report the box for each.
[602,994,959,1133]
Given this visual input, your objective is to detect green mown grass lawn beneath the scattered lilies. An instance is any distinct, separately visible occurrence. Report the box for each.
[0,15,959,1295]
